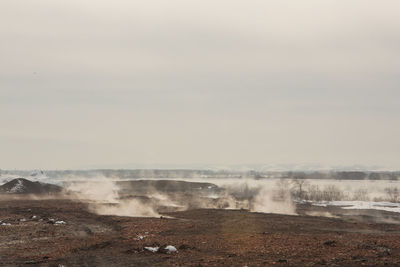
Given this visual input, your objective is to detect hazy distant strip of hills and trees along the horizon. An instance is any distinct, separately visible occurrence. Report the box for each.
[0,169,400,180]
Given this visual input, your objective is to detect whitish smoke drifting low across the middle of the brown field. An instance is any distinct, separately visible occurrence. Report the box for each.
[66,178,295,217]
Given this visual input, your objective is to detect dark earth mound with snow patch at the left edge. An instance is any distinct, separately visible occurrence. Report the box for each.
[0,178,62,194]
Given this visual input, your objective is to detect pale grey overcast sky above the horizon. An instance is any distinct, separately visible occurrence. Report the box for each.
[0,0,400,169]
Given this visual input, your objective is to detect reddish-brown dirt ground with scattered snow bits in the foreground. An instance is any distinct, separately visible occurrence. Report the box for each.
[0,198,400,267]
